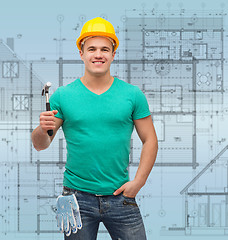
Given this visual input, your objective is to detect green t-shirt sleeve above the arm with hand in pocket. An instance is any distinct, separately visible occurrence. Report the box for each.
[132,86,150,120]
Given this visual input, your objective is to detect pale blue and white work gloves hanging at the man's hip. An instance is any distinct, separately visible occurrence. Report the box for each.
[56,194,82,236]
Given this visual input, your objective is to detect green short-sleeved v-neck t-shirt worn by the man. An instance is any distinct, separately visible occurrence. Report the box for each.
[50,78,150,195]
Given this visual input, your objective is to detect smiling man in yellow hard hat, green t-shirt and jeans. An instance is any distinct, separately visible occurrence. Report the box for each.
[32,18,158,240]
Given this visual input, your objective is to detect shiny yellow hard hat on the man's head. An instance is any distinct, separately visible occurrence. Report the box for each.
[76,17,119,51]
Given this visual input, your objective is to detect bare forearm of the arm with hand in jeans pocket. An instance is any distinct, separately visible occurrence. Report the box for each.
[134,140,158,187]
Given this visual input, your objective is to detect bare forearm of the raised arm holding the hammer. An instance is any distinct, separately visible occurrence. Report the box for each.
[32,126,51,151]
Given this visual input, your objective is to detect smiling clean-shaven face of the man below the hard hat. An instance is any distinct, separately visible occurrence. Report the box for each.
[79,37,115,76]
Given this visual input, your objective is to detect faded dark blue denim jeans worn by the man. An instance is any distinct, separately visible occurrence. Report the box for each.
[64,190,146,240]
